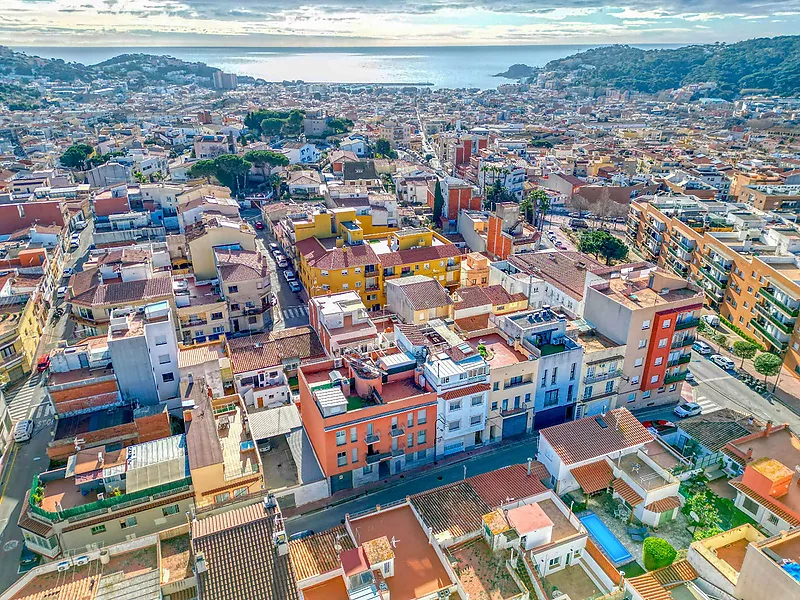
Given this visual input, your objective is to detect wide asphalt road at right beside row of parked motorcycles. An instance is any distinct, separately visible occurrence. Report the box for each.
[636,351,800,431]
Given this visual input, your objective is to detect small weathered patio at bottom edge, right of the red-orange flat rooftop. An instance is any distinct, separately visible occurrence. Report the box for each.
[450,539,522,600]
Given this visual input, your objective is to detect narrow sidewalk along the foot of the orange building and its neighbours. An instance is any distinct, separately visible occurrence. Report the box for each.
[282,434,539,519]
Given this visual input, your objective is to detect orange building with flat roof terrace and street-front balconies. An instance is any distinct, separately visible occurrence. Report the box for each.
[298,354,436,494]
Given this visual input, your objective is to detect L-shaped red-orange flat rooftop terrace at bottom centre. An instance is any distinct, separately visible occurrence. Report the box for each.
[350,505,451,600]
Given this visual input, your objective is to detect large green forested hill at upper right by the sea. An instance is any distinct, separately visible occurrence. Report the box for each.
[543,36,800,99]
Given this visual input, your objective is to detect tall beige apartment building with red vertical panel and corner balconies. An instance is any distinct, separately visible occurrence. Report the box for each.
[584,263,703,409]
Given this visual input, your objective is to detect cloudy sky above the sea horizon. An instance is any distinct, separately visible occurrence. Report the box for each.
[0,0,800,47]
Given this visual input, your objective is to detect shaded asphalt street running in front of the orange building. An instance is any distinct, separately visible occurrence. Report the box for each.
[286,436,537,534]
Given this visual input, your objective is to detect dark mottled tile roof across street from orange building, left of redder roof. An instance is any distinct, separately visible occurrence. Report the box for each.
[411,481,491,538]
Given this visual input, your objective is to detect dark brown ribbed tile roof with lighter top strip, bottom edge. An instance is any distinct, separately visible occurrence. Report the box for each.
[192,502,299,600]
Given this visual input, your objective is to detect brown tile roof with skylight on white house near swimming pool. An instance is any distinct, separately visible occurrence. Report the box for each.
[540,408,654,465]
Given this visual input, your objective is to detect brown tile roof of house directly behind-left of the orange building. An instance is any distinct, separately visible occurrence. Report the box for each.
[228,325,325,373]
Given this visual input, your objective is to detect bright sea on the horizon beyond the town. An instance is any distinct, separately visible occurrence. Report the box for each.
[14,45,677,89]
